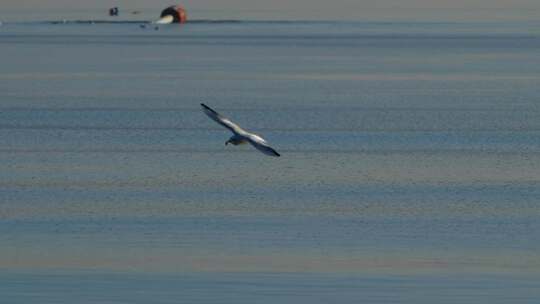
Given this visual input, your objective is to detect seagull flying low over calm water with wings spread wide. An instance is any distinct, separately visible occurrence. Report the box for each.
[201,103,280,157]
